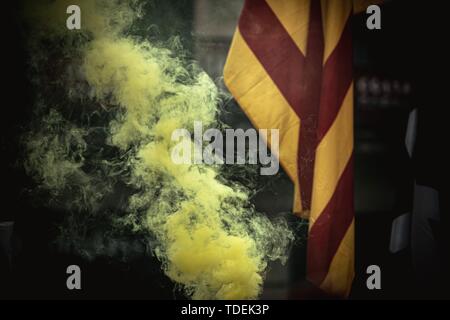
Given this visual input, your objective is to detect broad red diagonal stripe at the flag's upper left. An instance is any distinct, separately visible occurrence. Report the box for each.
[239,0,305,116]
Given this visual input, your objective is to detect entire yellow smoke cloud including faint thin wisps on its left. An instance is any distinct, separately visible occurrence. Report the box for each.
[23,0,293,299]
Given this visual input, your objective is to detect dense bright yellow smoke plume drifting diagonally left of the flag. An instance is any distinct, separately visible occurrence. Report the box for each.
[22,0,292,299]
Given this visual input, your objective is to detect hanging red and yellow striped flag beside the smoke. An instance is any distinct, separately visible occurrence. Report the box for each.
[224,0,354,296]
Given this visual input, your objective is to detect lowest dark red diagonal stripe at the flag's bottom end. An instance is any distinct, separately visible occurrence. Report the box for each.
[307,156,353,284]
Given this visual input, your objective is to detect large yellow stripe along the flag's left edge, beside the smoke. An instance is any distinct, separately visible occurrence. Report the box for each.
[224,30,300,185]
